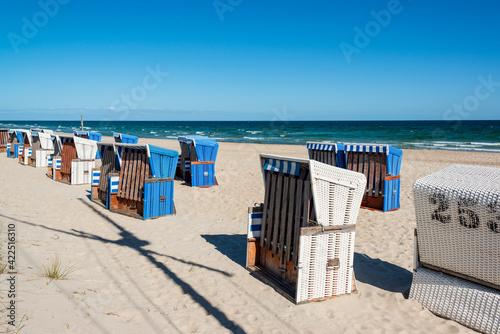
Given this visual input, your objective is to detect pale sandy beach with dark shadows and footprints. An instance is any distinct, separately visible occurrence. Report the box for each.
[0,138,500,333]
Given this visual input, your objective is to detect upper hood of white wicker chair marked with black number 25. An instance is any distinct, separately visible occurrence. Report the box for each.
[413,165,500,287]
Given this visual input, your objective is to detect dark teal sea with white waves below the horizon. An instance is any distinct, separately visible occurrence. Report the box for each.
[0,121,500,153]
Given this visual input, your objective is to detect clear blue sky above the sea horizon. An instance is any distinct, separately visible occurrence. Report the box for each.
[0,0,500,121]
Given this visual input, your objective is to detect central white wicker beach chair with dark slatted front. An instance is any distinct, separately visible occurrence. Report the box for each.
[246,154,366,304]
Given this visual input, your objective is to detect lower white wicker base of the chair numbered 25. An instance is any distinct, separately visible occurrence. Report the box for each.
[410,267,500,333]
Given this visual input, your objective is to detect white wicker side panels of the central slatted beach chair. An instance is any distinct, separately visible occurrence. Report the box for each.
[296,160,366,303]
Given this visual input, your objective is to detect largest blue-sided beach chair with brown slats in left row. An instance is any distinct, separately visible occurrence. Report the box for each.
[91,143,179,219]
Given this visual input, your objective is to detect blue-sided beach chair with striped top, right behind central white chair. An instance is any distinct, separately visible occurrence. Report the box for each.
[344,144,403,212]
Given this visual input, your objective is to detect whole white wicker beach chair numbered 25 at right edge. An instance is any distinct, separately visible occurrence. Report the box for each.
[410,165,500,333]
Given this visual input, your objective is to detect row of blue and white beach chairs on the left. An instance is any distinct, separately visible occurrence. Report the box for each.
[0,129,219,219]
